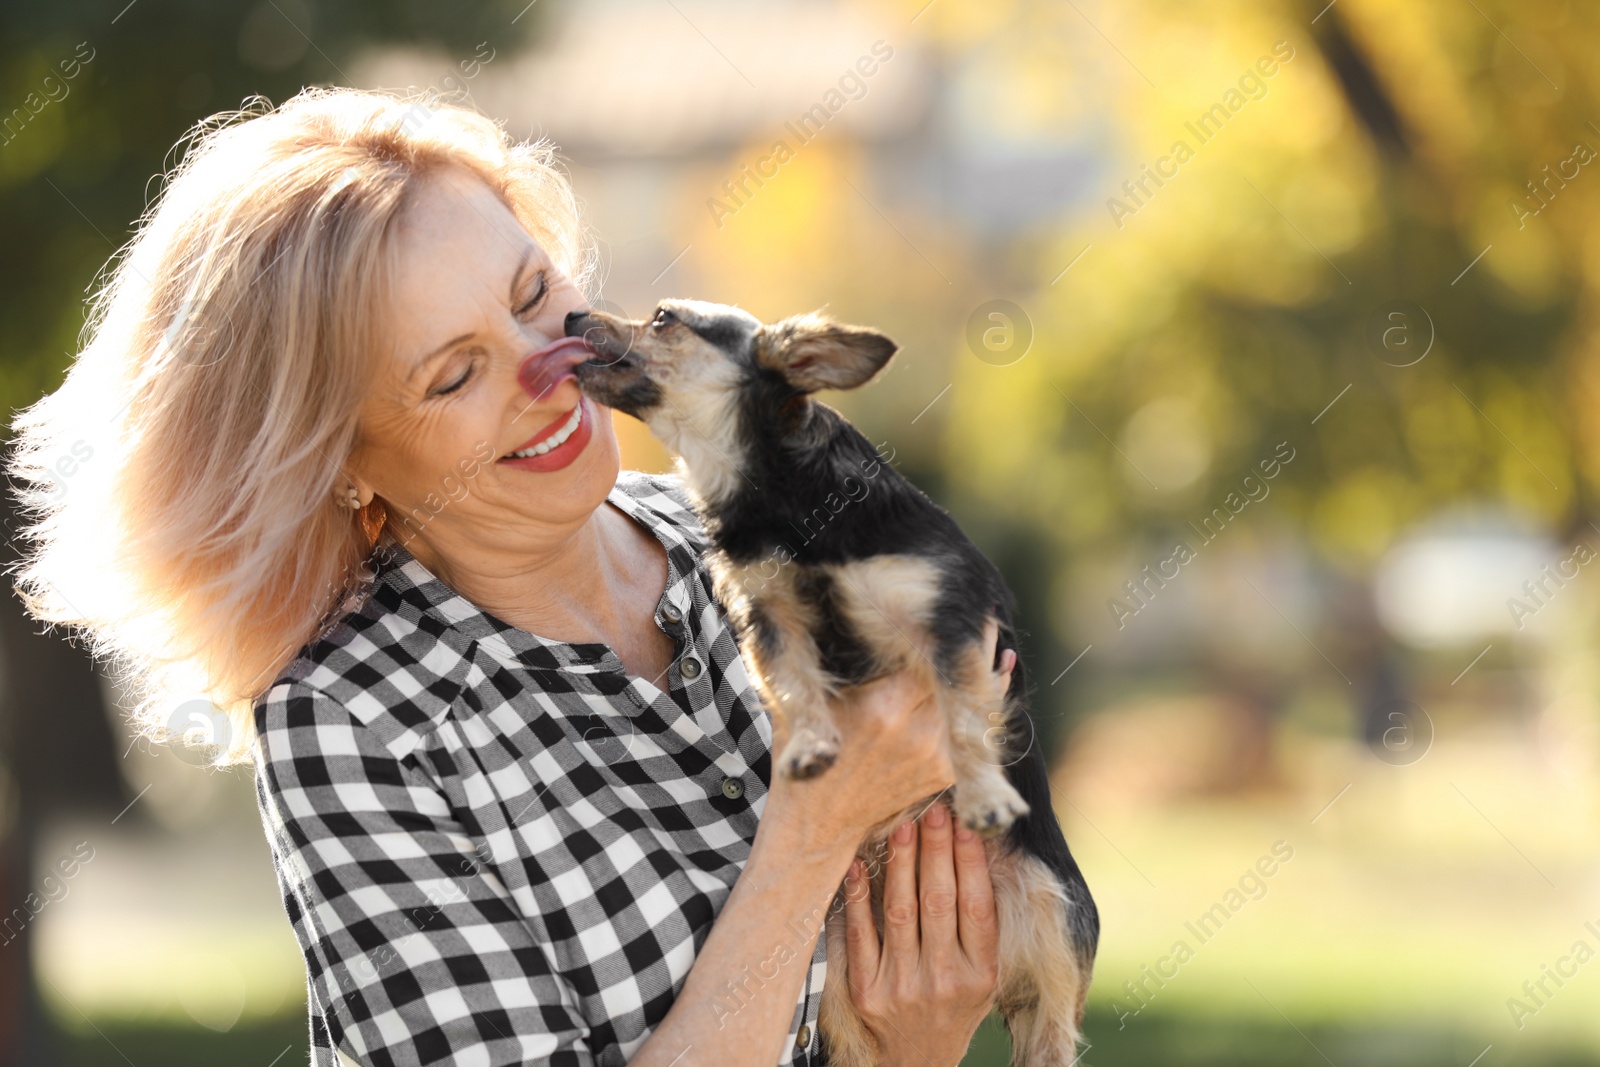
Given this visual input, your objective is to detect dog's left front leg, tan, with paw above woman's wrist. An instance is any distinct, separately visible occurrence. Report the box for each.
[710,555,838,777]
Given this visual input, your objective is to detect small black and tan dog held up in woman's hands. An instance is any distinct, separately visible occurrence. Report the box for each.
[566,301,1099,1067]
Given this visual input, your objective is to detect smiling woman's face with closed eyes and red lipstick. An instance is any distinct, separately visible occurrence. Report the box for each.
[347,170,619,563]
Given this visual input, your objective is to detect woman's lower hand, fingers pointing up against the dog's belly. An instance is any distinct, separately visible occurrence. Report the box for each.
[845,635,1016,1067]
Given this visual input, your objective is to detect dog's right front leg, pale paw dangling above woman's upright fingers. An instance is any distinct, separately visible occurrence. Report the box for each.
[941,633,1034,835]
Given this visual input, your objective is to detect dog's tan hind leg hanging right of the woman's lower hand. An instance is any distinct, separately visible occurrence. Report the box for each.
[985,845,1093,1067]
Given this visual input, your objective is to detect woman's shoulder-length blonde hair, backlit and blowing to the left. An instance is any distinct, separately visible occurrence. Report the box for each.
[8,90,595,763]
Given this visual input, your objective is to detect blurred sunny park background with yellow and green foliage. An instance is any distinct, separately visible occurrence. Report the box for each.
[0,0,1600,1067]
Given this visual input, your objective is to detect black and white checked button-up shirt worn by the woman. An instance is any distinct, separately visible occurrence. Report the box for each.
[254,472,826,1067]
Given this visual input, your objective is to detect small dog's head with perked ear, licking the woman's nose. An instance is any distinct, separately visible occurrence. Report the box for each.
[566,301,896,494]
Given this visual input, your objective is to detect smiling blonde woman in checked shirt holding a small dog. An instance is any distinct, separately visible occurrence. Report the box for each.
[11,90,1010,1067]
